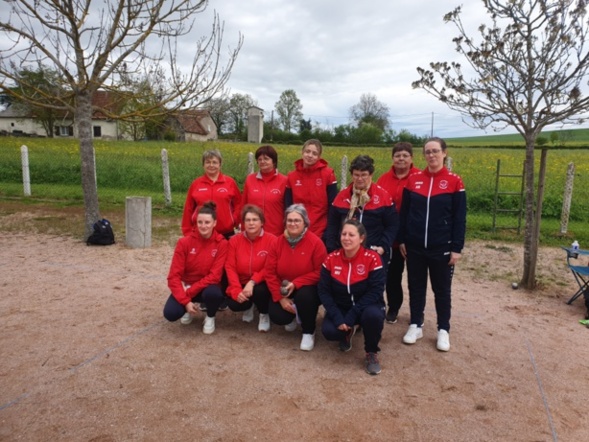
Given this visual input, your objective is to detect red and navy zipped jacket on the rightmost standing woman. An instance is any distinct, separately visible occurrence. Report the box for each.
[397,167,466,253]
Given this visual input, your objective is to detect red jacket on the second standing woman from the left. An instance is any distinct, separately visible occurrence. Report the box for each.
[243,170,286,236]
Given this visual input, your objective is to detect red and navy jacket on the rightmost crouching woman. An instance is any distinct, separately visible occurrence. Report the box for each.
[318,247,385,327]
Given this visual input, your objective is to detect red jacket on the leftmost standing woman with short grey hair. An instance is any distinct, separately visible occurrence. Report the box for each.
[182,173,241,236]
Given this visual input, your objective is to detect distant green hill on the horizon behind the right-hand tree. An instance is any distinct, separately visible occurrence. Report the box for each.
[446,129,589,147]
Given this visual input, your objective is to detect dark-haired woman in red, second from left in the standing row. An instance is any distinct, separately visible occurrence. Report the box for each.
[242,145,286,236]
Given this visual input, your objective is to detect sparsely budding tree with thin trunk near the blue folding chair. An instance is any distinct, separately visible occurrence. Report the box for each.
[413,0,589,289]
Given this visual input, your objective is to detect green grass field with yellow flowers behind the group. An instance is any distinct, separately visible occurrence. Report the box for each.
[0,135,589,244]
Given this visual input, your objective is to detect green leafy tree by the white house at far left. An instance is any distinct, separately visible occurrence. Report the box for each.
[12,65,65,138]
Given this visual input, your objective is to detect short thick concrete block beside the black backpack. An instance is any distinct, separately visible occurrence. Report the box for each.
[125,196,151,249]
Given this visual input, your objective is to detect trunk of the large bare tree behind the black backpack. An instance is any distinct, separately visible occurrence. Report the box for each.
[75,91,100,239]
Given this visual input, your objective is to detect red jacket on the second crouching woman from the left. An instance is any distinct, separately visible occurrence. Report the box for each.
[225,231,276,300]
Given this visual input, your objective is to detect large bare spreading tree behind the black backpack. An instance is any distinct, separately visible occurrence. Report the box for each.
[0,0,243,237]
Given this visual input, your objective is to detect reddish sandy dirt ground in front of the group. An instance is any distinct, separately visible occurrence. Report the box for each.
[0,233,589,441]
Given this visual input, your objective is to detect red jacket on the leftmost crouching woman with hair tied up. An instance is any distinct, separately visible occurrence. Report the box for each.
[168,232,227,305]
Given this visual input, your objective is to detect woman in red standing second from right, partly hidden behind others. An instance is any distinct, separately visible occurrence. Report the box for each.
[376,141,419,324]
